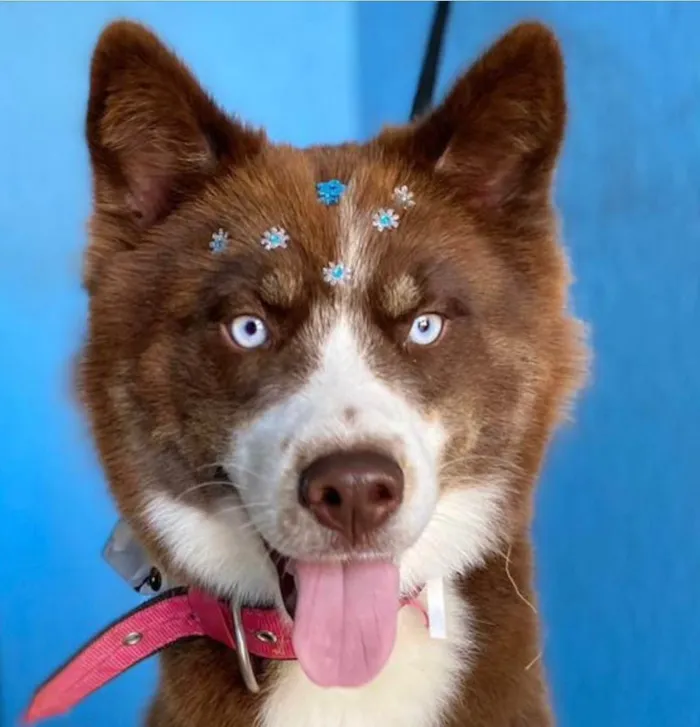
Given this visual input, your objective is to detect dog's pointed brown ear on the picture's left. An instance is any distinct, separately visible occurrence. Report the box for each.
[87,22,264,227]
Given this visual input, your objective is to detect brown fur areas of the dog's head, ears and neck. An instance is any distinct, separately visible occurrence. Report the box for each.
[80,17,584,727]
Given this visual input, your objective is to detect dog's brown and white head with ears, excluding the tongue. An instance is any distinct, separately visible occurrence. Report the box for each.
[81,17,580,684]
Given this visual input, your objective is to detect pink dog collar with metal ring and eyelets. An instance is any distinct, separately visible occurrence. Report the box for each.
[24,588,427,723]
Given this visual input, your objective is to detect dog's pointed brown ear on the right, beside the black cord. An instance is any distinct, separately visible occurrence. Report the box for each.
[378,23,566,211]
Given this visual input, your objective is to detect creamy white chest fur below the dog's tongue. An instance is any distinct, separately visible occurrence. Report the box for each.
[260,586,474,727]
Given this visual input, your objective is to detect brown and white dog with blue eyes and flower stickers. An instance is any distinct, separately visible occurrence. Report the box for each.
[72,21,587,727]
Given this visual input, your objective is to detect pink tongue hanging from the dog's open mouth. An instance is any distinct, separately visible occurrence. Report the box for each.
[292,563,399,687]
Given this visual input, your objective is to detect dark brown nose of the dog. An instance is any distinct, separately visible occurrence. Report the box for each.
[299,450,403,544]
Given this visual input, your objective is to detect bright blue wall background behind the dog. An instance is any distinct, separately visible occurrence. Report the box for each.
[0,2,700,727]
